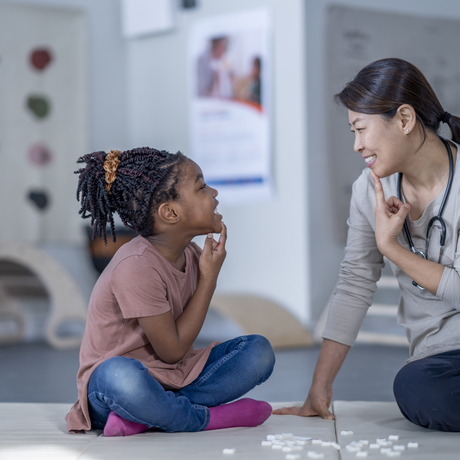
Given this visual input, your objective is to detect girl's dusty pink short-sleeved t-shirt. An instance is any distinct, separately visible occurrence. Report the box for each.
[66,236,218,432]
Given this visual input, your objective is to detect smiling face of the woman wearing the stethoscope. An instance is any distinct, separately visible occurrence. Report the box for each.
[348,110,406,177]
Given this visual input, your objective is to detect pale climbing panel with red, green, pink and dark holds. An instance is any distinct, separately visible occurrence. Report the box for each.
[0,3,88,243]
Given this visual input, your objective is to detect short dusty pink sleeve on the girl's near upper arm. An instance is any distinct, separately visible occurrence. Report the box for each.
[111,255,171,319]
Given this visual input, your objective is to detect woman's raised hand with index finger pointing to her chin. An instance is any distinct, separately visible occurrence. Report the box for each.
[371,172,410,255]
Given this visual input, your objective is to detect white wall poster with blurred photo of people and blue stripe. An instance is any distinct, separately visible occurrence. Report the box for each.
[189,9,273,205]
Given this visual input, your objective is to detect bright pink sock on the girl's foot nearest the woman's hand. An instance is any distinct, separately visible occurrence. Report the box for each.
[204,398,272,431]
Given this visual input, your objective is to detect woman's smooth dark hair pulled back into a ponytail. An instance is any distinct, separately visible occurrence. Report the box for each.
[335,58,460,143]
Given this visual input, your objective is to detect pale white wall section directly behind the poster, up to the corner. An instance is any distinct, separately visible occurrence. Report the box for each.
[127,0,310,322]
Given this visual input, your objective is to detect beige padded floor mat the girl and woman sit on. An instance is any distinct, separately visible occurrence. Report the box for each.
[0,401,460,460]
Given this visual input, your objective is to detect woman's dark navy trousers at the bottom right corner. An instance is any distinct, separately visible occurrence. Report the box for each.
[393,350,460,431]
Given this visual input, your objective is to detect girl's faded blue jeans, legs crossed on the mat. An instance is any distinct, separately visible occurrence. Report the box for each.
[88,335,275,432]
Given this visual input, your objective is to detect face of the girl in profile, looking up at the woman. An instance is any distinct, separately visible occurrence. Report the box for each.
[177,159,222,235]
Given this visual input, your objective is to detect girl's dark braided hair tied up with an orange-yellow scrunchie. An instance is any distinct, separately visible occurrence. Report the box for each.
[75,147,187,244]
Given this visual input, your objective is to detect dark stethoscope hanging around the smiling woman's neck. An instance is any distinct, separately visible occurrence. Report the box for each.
[398,136,454,291]
